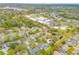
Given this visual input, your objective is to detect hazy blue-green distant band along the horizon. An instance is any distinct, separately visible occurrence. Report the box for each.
[0,3,79,8]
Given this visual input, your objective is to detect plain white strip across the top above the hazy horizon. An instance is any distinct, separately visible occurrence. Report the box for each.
[0,0,79,4]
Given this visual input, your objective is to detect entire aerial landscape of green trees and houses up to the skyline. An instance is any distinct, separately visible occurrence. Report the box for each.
[0,4,79,55]
